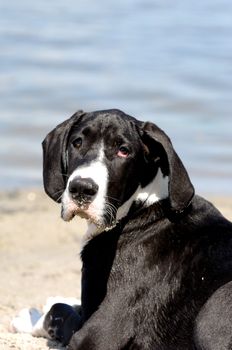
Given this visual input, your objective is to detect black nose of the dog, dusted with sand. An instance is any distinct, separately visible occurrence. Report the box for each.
[68,176,98,202]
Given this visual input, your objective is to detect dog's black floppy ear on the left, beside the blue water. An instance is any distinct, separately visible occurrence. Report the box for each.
[42,111,84,202]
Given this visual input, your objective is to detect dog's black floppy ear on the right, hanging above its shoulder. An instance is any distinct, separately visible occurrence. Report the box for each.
[141,122,194,213]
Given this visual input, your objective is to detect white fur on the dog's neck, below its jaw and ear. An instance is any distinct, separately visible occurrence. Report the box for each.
[82,168,169,248]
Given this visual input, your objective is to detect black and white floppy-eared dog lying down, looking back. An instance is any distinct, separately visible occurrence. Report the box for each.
[43,110,232,350]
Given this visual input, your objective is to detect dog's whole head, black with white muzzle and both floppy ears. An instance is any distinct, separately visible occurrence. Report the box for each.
[43,110,194,229]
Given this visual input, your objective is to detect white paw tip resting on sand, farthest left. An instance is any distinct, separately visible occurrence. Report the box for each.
[10,308,42,333]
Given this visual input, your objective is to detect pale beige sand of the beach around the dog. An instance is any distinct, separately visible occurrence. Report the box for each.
[0,190,232,350]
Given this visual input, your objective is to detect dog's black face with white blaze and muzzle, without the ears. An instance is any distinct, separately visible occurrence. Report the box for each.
[62,113,157,227]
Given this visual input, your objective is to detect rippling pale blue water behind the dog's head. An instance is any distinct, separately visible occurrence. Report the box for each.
[0,0,232,195]
